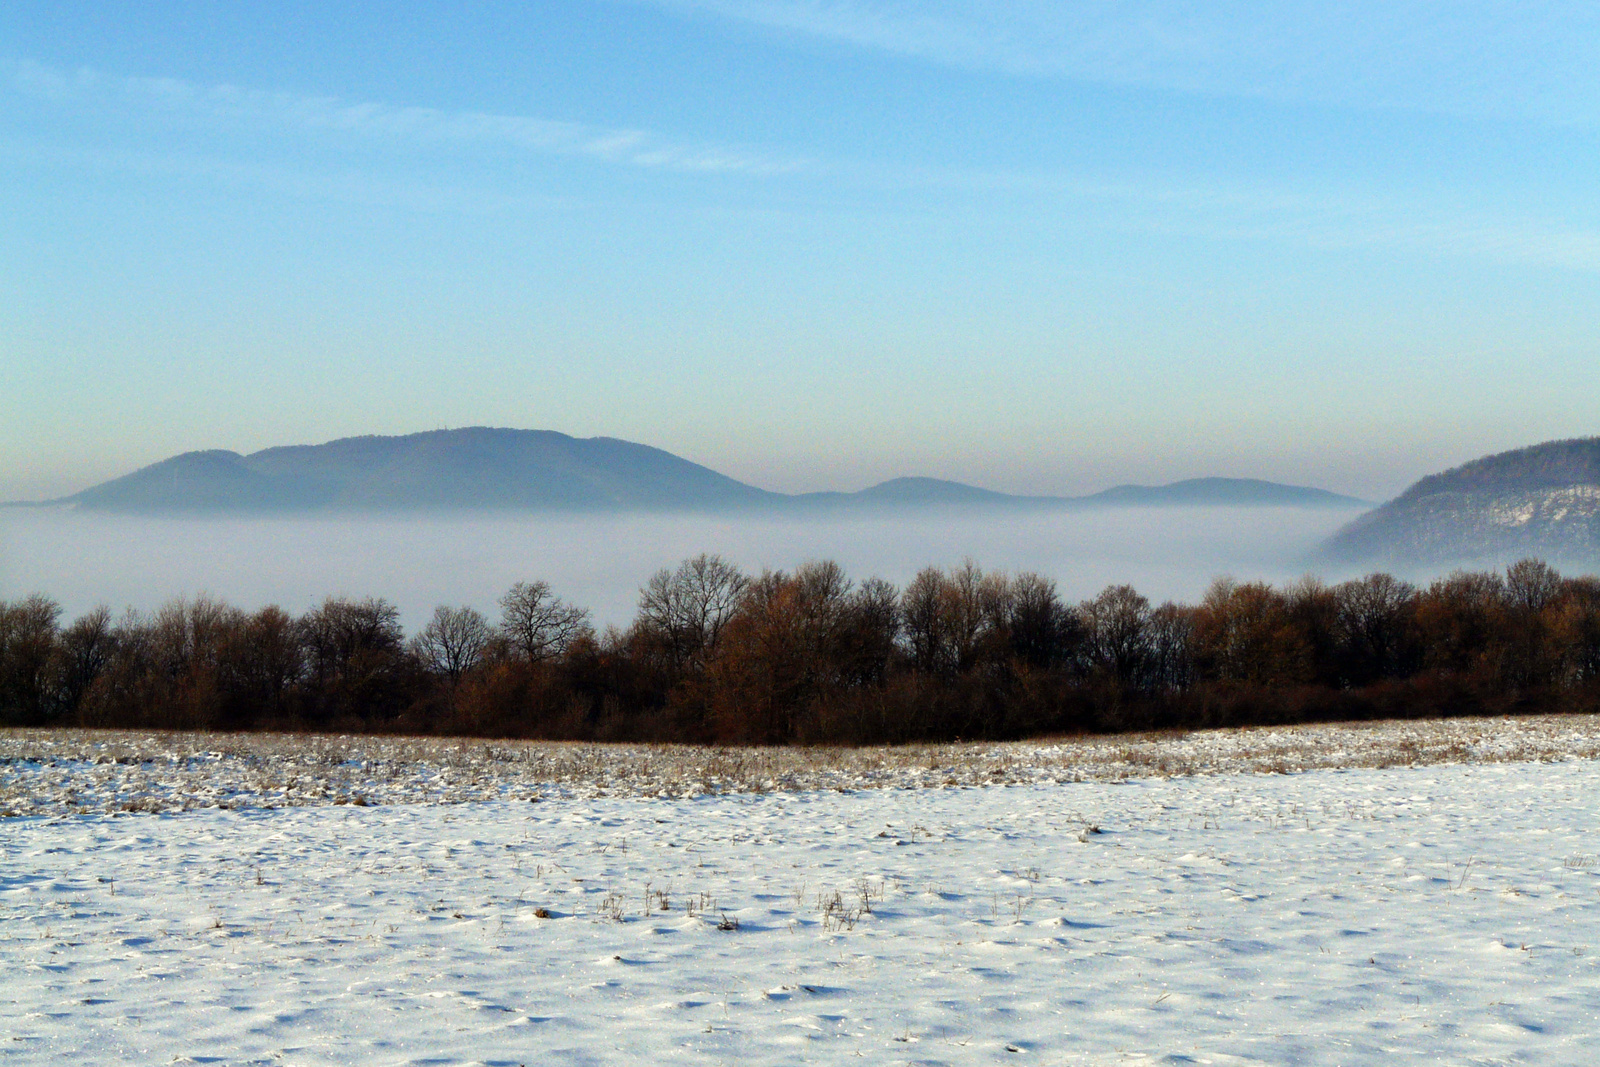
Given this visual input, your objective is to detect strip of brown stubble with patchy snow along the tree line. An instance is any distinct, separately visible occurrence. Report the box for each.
[0,715,1600,817]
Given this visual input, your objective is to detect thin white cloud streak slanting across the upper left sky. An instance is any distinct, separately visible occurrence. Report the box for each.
[10,61,806,176]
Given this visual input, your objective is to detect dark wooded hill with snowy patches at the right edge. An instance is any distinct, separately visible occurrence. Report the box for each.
[1323,437,1600,565]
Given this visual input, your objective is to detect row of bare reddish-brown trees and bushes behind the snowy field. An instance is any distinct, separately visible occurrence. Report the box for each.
[0,555,1600,744]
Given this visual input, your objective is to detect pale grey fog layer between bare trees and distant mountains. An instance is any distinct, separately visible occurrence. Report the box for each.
[0,507,1376,629]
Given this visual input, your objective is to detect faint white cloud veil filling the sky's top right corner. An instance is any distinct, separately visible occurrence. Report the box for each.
[635,0,1600,126]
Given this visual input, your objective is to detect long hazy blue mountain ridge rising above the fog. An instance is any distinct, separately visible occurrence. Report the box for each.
[25,427,1365,514]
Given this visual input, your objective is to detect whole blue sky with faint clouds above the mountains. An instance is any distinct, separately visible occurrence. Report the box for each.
[0,0,1600,498]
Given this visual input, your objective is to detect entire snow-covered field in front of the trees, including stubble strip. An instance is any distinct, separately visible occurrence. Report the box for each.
[0,718,1600,1067]
